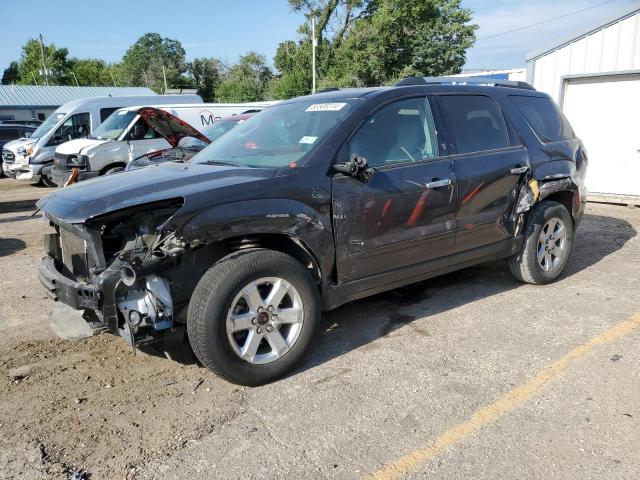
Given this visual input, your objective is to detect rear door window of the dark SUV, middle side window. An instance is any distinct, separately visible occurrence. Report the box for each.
[440,95,510,153]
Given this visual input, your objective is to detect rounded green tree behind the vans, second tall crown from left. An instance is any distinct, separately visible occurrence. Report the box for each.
[122,33,187,93]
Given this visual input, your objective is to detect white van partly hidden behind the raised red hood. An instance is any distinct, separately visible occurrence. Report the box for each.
[52,102,277,187]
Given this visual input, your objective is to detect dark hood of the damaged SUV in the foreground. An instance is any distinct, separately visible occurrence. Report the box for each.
[37,162,276,223]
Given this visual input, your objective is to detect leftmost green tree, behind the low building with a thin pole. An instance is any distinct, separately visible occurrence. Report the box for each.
[17,38,75,85]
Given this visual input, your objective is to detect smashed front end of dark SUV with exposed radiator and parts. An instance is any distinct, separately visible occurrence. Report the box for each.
[38,200,184,345]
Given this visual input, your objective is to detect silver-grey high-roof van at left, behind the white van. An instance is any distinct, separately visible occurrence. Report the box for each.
[2,95,202,186]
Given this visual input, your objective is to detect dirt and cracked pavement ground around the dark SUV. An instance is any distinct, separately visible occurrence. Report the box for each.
[0,179,640,480]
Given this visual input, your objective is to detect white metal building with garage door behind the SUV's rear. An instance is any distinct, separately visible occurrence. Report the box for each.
[527,1,640,204]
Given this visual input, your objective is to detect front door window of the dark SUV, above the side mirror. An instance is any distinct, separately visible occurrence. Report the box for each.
[349,97,438,166]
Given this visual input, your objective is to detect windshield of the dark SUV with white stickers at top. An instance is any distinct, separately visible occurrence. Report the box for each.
[192,100,355,168]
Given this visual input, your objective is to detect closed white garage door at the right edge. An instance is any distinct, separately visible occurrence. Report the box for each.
[563,75,640,195]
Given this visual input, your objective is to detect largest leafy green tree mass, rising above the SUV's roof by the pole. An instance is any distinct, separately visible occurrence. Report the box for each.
[272,0,477,93]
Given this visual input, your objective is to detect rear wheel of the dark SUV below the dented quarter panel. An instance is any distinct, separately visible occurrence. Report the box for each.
[509,201,574,285]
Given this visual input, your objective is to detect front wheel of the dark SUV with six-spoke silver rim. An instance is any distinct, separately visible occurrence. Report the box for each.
[187,249,320,386]
